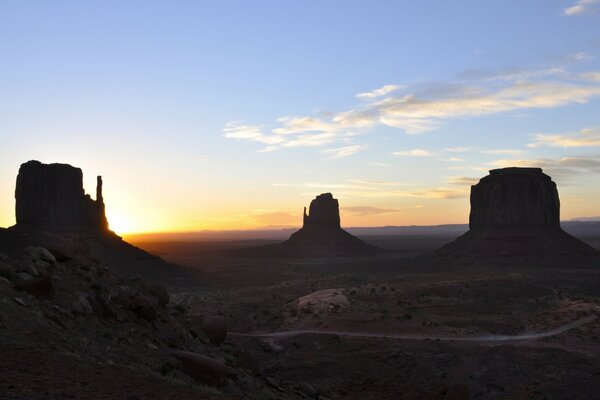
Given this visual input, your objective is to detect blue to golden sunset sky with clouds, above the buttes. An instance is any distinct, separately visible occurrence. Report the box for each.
[0,0,600,234]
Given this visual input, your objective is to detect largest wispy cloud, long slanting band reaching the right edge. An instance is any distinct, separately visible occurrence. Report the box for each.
[223,65,600,152]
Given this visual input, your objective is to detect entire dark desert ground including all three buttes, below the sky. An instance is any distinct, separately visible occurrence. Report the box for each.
[0,161,600,399]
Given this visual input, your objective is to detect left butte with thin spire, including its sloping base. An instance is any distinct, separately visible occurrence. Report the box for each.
[0,161,175,281]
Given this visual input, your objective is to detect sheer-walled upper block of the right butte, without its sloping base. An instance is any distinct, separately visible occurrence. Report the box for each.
[469,167,560,230]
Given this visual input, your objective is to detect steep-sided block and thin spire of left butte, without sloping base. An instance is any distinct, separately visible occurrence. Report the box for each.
[15,161,108,231]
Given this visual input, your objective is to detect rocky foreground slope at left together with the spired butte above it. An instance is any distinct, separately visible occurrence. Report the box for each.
[0,162,314,400]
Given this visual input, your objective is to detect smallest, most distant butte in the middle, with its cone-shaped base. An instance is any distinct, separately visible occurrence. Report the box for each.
[282,193,377,256]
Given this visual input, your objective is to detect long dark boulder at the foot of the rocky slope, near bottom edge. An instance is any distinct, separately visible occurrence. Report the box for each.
[173,351,237,386]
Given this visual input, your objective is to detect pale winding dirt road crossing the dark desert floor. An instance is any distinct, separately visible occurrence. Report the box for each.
[229,315,597,342]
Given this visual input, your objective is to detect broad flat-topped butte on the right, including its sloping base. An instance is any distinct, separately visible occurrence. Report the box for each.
[435,167,598,266]
